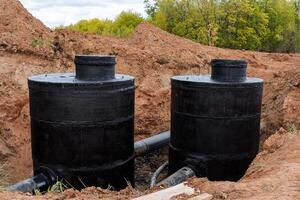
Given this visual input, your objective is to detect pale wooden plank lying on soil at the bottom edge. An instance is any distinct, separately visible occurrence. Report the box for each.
[134,183,195,200]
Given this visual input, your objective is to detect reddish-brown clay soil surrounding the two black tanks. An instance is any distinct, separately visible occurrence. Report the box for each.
[0,0,300,199]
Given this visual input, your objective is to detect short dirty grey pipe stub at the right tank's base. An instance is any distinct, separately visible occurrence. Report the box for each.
[157,167,195,187]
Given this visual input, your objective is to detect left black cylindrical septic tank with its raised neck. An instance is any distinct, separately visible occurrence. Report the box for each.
[28,56,135,189]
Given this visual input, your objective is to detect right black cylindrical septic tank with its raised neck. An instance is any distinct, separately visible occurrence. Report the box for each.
[169,59,263,181]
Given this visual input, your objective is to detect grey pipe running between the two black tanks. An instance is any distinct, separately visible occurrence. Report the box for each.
[134,131,170,156]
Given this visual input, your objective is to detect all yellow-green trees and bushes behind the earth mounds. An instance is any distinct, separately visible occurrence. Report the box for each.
[64,0,300,52]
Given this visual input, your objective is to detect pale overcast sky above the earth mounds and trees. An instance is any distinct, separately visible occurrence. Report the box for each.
[20,0,145,28]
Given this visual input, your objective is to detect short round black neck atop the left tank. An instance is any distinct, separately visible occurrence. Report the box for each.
[75,55,116,81]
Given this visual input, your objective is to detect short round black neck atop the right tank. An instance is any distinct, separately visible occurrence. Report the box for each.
[211,59,247,82]
